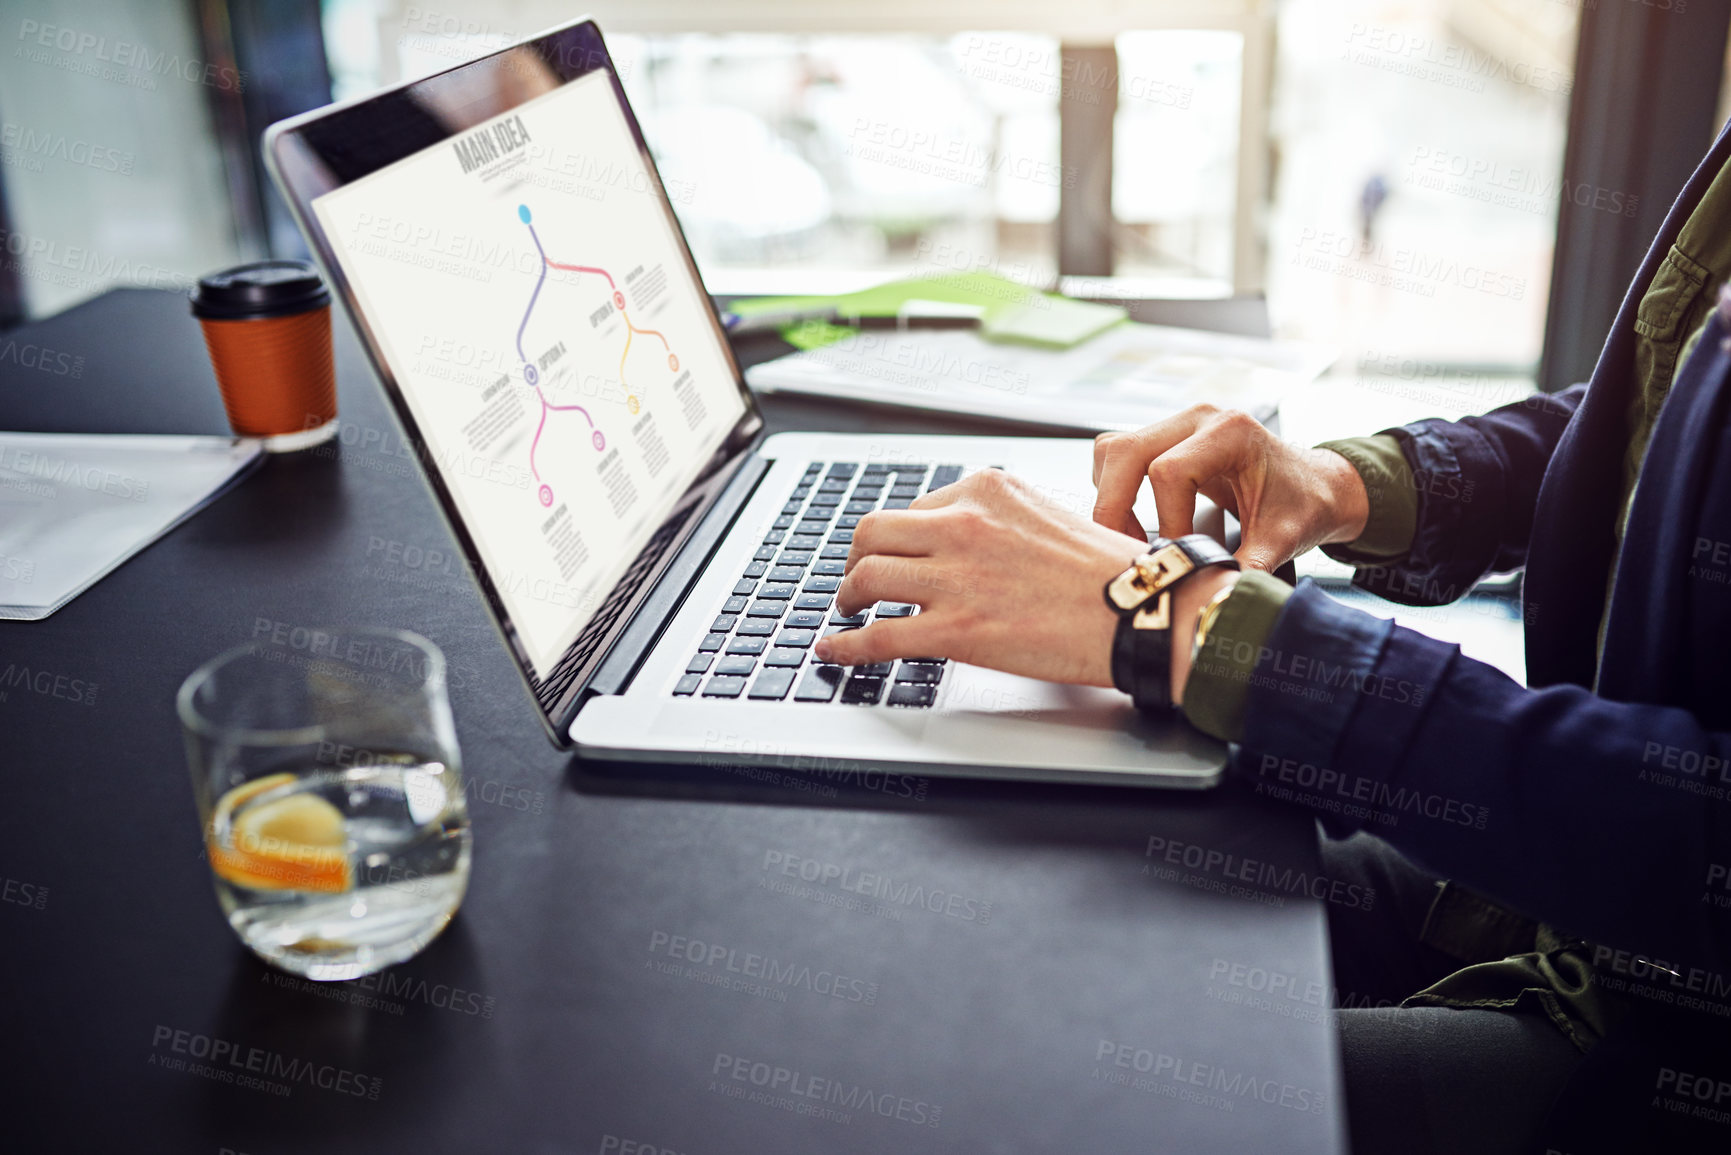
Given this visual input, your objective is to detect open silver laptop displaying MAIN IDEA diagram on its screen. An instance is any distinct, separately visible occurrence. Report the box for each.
[265,19,1226,788]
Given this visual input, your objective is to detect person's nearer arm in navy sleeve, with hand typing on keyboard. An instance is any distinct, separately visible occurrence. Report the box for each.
[817,469,1731,973]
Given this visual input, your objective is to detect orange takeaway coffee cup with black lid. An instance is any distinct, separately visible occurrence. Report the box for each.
[192,261,336,454]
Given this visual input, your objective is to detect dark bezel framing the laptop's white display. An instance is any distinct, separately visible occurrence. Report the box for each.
[263,17,763,748]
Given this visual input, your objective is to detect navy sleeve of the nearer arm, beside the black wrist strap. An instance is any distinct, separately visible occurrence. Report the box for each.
[1234,578,1731,973]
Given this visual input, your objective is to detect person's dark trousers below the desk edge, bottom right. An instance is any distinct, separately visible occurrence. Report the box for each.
[1321,833,1584,1155]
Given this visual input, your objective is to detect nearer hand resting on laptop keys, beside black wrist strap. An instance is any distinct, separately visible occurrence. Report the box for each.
[817,469,1148,686]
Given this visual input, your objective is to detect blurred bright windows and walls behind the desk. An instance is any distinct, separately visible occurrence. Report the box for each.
[0,0,1726,398]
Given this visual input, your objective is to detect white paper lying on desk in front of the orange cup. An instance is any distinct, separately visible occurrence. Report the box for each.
[0,433,261,622]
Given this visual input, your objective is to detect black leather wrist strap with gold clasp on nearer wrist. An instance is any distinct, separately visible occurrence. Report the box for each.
[1106,533,1238,712]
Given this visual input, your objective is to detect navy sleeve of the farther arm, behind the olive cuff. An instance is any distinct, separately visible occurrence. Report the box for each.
[1354,384,1587,606]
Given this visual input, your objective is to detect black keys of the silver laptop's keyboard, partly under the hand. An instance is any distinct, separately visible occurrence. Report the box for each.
[673,461,962,707]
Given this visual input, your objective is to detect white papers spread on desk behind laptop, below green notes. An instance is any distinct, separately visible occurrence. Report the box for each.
[746,324,1335,433]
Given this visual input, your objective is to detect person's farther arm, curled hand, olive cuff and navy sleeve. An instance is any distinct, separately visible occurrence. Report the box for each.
[1094,384,1586,606]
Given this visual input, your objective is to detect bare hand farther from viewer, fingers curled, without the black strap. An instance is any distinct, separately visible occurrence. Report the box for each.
[1094,405,1369,570]
